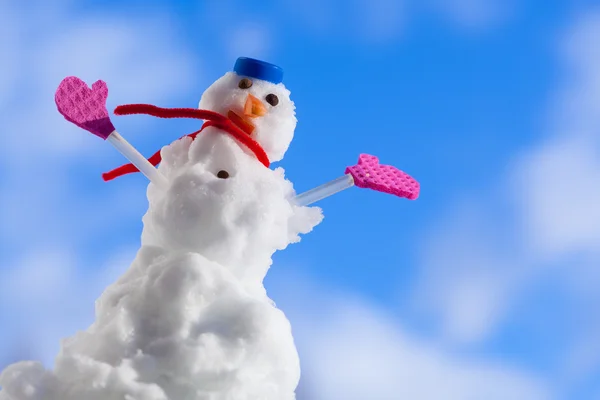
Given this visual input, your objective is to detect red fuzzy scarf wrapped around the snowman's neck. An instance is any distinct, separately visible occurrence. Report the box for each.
[102,104,270,181]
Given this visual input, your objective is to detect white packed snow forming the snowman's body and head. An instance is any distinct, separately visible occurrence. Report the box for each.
[0,73,322,400]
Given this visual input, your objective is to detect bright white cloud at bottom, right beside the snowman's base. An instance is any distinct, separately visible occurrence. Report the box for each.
[273,276,552,400]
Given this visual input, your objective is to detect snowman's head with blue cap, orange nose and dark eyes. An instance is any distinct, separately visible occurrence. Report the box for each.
[199,57,297,162]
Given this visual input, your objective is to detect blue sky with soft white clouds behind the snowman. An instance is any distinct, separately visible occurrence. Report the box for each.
[0,0,600,400]
